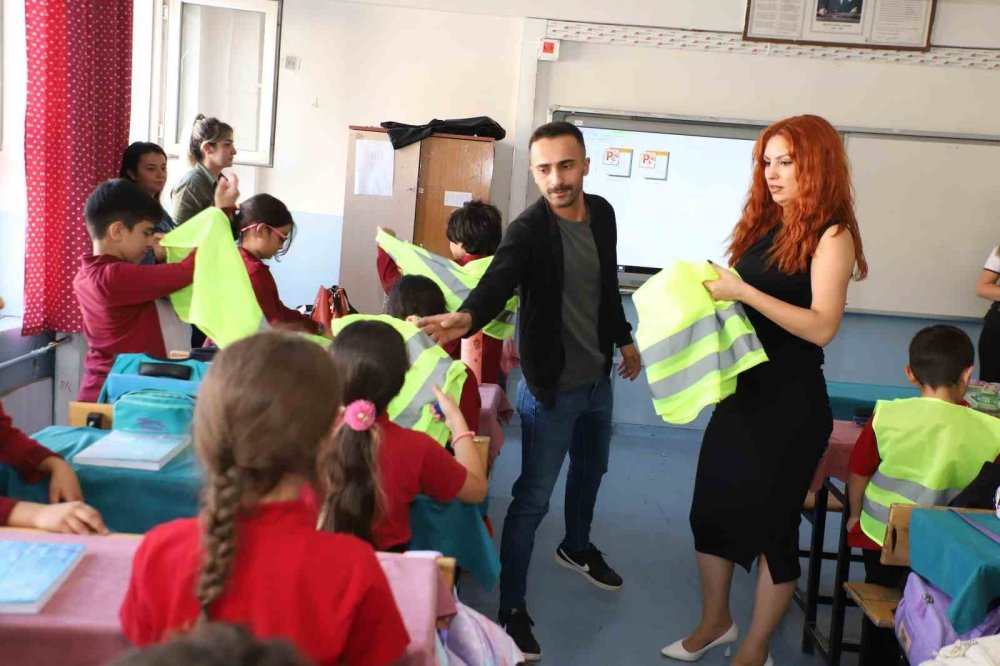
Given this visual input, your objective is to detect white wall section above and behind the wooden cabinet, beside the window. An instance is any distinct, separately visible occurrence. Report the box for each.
[258,0,522,215]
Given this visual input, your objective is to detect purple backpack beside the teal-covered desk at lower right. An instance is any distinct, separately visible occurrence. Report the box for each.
[895,511,1000,664]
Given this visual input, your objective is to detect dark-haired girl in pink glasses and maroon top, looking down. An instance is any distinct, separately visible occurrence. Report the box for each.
[232,194,325,335]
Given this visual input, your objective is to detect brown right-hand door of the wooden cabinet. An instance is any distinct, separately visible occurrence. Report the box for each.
[413,134,493,257]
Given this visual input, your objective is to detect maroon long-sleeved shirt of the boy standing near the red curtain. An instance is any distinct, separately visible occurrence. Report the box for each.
[73,252,194,402]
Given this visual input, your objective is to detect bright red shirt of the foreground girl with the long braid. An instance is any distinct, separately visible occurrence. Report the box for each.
[119,493,409,666]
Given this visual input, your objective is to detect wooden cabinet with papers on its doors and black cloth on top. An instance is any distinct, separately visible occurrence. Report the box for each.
[340,126,494,313]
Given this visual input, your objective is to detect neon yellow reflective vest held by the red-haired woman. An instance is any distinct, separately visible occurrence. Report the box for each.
[632,261,767,424]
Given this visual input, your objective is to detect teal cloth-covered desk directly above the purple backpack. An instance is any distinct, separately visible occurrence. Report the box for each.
[910,509,1000,634]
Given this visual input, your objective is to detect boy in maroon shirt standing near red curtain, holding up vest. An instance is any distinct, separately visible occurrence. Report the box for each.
[73,178,239,402]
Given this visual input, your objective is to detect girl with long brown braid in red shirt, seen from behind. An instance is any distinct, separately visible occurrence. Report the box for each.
[120,332,409,666]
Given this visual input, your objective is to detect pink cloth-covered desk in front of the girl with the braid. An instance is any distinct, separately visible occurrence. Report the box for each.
[0,528,456,666]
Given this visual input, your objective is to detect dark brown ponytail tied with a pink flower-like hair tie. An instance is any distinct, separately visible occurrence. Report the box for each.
[320,400,381,543]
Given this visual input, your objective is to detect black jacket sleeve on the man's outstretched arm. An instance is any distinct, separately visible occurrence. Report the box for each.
[459,220,533,334]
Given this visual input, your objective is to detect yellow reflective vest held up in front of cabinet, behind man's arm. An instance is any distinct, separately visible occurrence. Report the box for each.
[375,231,517,340]
